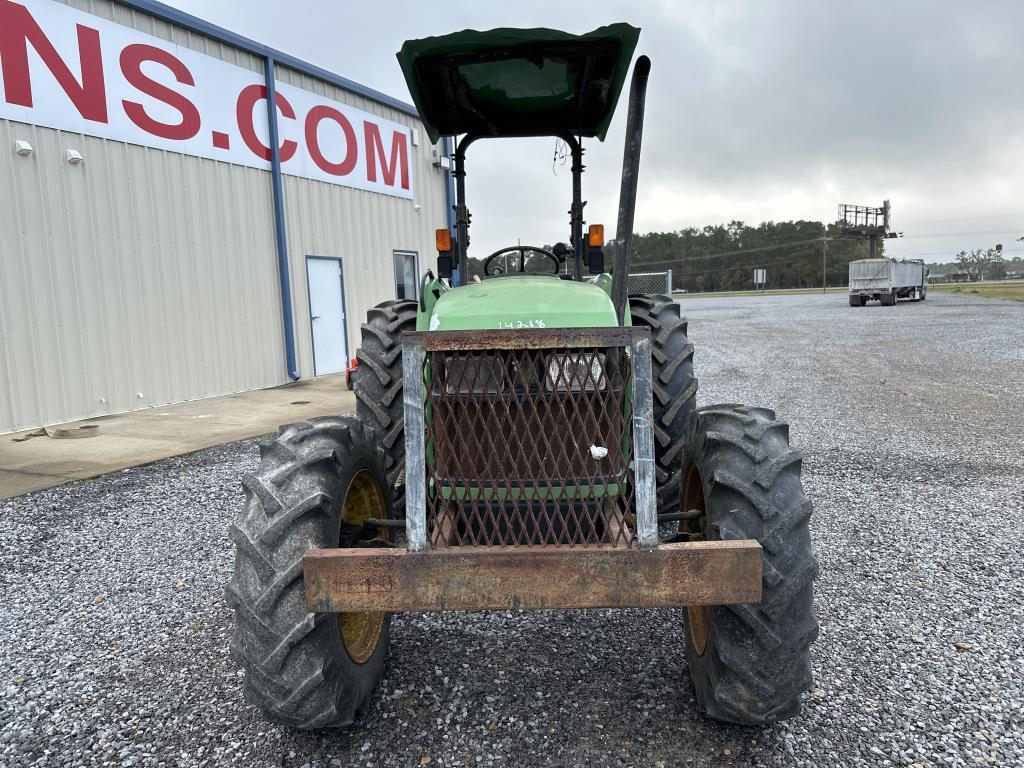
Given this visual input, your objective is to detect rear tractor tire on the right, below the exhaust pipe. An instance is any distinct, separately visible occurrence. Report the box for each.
[630,294,697,514]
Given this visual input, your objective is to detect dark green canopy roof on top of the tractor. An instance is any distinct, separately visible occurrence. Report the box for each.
[397,24,640,141]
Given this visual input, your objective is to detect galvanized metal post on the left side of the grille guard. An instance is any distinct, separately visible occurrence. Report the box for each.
[401,337,427,552]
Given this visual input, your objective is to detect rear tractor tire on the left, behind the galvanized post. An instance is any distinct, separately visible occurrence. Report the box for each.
[354,299,417,518]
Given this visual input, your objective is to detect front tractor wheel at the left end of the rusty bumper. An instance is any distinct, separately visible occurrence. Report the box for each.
[226,416,390,729]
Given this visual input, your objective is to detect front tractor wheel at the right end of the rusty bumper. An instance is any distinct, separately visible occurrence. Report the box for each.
[683,406,818,725]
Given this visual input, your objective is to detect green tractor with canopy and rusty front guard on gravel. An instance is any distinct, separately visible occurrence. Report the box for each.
[227,24,817,729]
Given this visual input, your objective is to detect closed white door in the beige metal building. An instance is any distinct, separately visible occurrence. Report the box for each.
[306,256,348,376]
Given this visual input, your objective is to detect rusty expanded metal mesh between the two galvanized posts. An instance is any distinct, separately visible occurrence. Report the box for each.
[424,333,636,548]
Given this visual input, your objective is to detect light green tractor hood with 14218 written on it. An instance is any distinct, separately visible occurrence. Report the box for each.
[429,274,617,331]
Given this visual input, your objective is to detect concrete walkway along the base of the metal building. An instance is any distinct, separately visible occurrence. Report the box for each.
[0,374,355,499]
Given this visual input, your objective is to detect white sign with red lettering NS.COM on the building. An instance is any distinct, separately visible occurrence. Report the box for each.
[0,0,417,200]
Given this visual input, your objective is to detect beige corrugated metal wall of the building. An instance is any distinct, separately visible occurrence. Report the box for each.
[0,0,446,432]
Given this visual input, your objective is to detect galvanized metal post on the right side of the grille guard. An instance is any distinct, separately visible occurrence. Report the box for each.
[626,334,657,547]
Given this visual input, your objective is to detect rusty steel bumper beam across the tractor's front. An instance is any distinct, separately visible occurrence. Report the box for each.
[303,540,762,612]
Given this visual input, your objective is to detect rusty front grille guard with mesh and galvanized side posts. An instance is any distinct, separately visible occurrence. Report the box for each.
[402,328,657,551]
